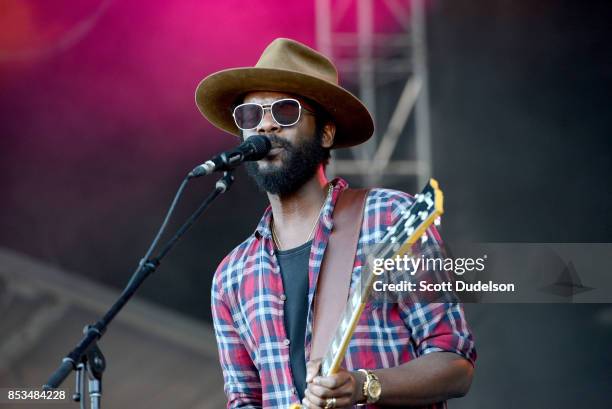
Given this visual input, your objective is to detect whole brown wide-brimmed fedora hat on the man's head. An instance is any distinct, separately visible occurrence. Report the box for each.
[196,38,374,148]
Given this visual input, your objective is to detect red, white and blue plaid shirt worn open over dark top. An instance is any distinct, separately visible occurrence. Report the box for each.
[211,179,476,409]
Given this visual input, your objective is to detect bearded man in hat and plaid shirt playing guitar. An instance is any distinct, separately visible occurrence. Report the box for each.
[196,39,476,408]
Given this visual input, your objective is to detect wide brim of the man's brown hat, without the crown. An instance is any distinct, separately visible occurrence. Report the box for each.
[196,67,374,149]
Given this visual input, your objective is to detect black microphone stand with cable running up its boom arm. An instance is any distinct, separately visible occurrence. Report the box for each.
[43,169,234,409]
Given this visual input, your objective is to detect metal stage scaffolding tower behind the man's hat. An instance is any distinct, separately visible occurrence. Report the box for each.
[315,0,432,186]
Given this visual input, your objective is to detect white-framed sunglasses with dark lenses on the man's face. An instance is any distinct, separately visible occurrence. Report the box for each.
[232,98,314,131]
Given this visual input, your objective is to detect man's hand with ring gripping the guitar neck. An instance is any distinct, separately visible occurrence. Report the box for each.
[302,359,364,409]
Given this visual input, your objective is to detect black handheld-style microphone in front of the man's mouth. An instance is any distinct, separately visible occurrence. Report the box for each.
[189,135,272,178]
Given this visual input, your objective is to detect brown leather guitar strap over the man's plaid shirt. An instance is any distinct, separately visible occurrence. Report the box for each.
[310,189,369,360]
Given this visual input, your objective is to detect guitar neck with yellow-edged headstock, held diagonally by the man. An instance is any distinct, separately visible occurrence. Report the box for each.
[290,179,444,409]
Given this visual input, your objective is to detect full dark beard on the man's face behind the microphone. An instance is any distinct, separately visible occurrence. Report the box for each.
[245,132,328,196]
